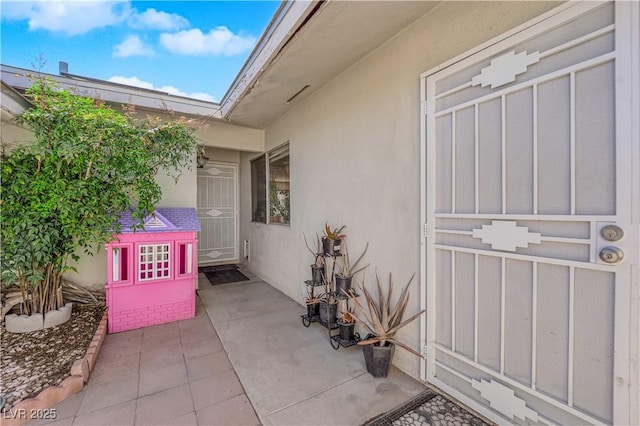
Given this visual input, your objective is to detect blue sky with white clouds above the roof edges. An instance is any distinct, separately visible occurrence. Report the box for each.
[0,0,280,101]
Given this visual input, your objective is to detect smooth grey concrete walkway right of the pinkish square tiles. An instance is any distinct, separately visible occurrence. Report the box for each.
[199,268,425,425]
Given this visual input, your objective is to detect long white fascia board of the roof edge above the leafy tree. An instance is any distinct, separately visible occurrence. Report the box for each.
[2,65,222,118]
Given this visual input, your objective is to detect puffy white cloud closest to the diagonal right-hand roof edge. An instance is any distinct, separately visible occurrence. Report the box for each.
[160,27,256,56]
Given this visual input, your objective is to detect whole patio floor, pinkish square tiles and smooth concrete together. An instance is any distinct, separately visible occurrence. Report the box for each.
[29,269,425,426]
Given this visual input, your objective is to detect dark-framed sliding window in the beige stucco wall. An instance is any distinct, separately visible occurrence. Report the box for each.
[251,142,291,224]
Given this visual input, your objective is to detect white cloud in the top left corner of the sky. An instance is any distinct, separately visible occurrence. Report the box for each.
[2,0,131,36]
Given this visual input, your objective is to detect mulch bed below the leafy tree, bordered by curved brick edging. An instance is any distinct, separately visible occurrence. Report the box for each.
[0,303,105,412]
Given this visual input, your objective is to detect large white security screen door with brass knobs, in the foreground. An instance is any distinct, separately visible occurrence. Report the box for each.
[422,2,638,424]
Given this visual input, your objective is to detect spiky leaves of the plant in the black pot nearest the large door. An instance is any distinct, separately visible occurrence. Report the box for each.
[343,274,425,358]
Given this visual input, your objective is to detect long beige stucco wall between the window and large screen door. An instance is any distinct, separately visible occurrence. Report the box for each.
[240,2,555,377]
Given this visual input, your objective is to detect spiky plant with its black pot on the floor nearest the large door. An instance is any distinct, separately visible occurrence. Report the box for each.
[344,274,425,377]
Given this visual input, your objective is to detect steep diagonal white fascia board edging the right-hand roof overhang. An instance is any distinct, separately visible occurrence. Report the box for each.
[220,0,318,117]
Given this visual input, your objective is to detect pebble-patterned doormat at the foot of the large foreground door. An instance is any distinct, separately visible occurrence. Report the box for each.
[363,389,489,426]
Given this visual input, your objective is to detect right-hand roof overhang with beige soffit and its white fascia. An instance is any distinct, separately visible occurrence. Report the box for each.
[222,0,440,129]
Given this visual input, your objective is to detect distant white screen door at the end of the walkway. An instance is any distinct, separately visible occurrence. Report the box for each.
[198,161,239,265]
